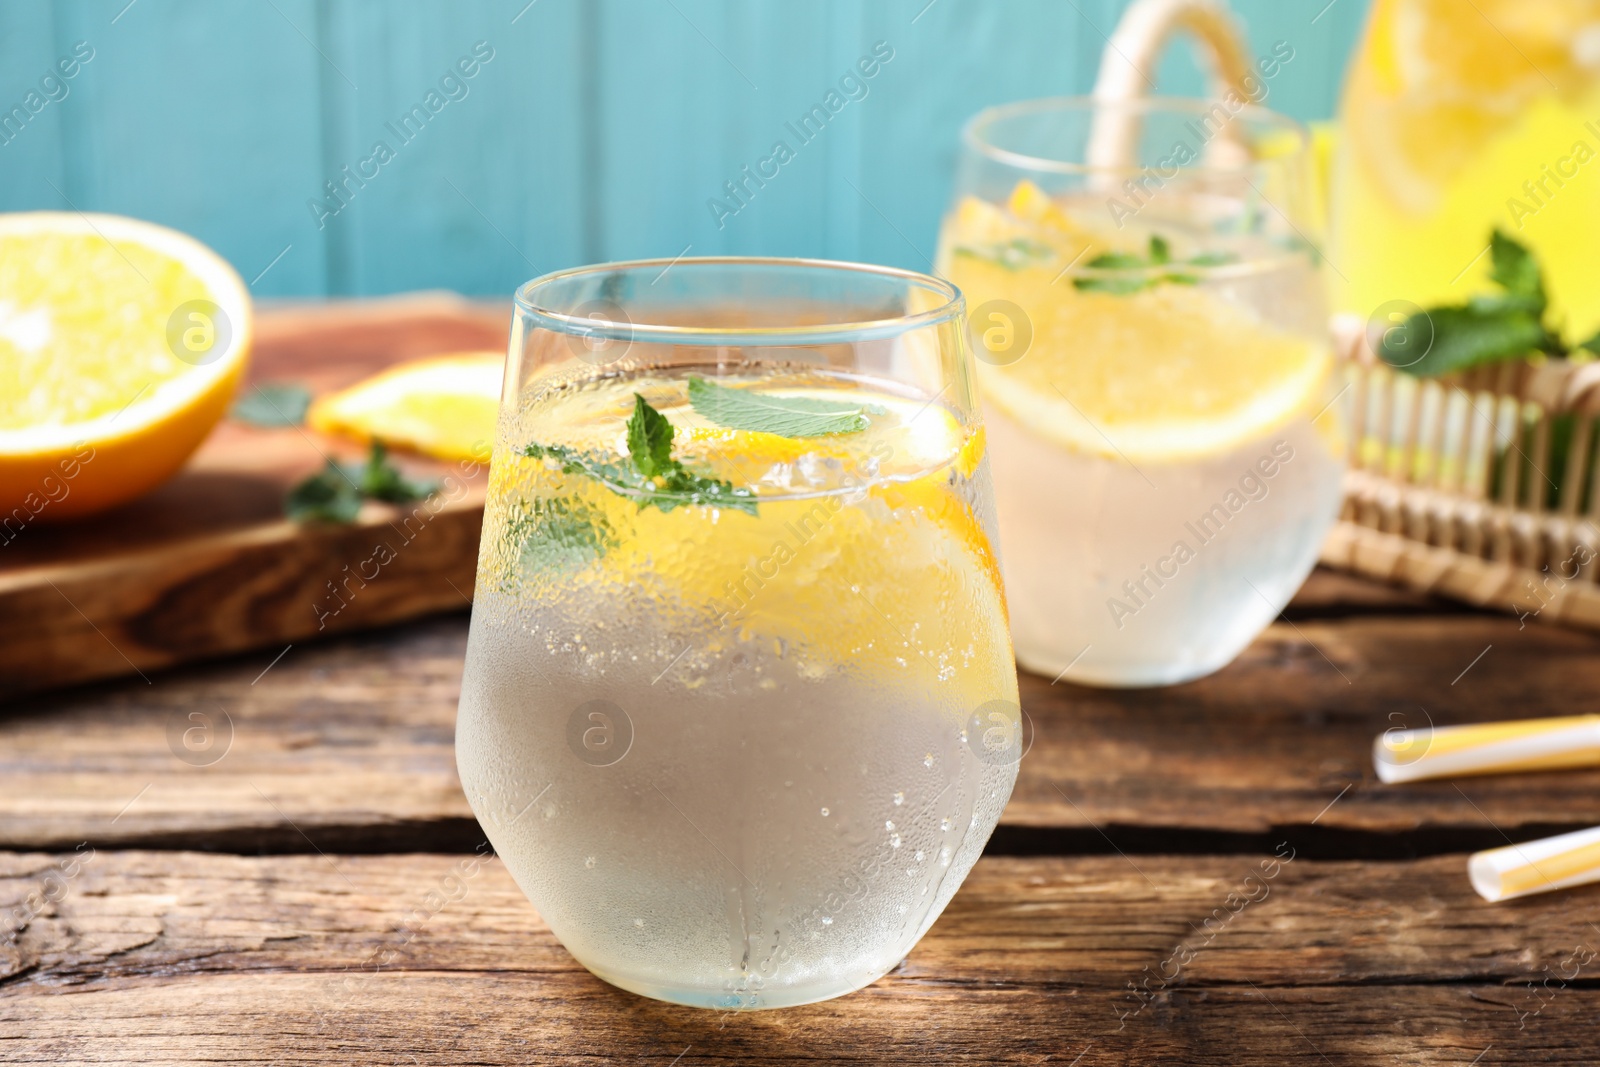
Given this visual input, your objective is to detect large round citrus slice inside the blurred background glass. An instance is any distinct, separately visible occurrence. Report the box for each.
[979,285,1331,462]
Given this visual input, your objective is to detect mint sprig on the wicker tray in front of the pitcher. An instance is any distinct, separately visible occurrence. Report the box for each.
[1374,229,1580,378]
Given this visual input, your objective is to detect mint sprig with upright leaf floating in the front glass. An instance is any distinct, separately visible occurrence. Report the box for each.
[522,394,757,515]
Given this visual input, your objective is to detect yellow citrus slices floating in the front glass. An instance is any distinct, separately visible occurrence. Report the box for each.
[508,379,1011,694]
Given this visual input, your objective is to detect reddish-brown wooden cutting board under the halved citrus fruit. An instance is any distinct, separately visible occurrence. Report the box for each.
[0,294,510,701]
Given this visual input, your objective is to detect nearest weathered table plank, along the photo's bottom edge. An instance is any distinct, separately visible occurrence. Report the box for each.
[0,851,1580,1065]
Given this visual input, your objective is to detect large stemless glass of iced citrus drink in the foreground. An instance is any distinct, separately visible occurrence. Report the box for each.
[456,259,1021,1008]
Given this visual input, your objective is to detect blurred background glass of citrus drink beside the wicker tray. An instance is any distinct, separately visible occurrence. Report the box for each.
[938,99,1342,686]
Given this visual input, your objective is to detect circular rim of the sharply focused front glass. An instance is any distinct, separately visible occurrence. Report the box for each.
[514,256,966,347]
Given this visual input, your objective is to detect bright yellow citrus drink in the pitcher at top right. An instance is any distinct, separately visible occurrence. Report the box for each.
[1328,0,1600,336]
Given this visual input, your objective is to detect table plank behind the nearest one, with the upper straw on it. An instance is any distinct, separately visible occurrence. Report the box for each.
[0,598,1600,857]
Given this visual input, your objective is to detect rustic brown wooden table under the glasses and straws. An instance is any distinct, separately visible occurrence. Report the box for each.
[0,573,1600,1067]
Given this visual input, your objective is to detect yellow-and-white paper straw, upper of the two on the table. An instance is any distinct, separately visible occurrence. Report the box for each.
[1373,715,1600,782]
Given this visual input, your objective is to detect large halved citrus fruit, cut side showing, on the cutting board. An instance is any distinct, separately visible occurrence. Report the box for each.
[0,211,251,518]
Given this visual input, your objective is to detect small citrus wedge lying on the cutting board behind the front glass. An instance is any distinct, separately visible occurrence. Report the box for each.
[306,352,506,462]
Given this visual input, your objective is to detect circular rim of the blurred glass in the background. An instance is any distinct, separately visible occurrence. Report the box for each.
[962,96,1312,176]
